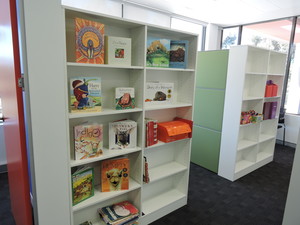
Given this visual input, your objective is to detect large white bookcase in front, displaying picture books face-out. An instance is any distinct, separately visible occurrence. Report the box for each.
[63,7,198,225]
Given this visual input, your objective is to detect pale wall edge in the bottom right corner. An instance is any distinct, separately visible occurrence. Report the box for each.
[283,129,300,225]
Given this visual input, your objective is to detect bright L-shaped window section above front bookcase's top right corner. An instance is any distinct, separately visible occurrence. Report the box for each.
[171,18,204,51]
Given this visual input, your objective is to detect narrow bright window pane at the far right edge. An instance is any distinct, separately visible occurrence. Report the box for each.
[285,17,300,114]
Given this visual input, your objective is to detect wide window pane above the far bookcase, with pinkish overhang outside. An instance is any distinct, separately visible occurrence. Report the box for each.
[241,19,292,53]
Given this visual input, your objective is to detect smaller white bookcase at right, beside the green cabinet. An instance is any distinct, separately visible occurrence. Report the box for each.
[218,46,287,181]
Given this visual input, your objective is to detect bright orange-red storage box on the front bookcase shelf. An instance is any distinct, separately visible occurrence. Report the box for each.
[157,118,193,143]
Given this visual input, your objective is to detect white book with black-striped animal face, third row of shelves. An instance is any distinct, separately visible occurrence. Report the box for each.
[109,120,137,149]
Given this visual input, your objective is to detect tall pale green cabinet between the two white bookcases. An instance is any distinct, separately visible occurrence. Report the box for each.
[191,50,229,173]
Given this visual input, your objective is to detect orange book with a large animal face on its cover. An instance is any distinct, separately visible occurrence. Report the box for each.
[101,157,130,192]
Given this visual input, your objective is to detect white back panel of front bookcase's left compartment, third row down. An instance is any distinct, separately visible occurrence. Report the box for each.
[69,112,144,151]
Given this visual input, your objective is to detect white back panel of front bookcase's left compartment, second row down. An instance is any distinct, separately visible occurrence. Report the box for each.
[67,67,144,109]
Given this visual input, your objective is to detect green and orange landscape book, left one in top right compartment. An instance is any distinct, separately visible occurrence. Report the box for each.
[146,37,170,67]
